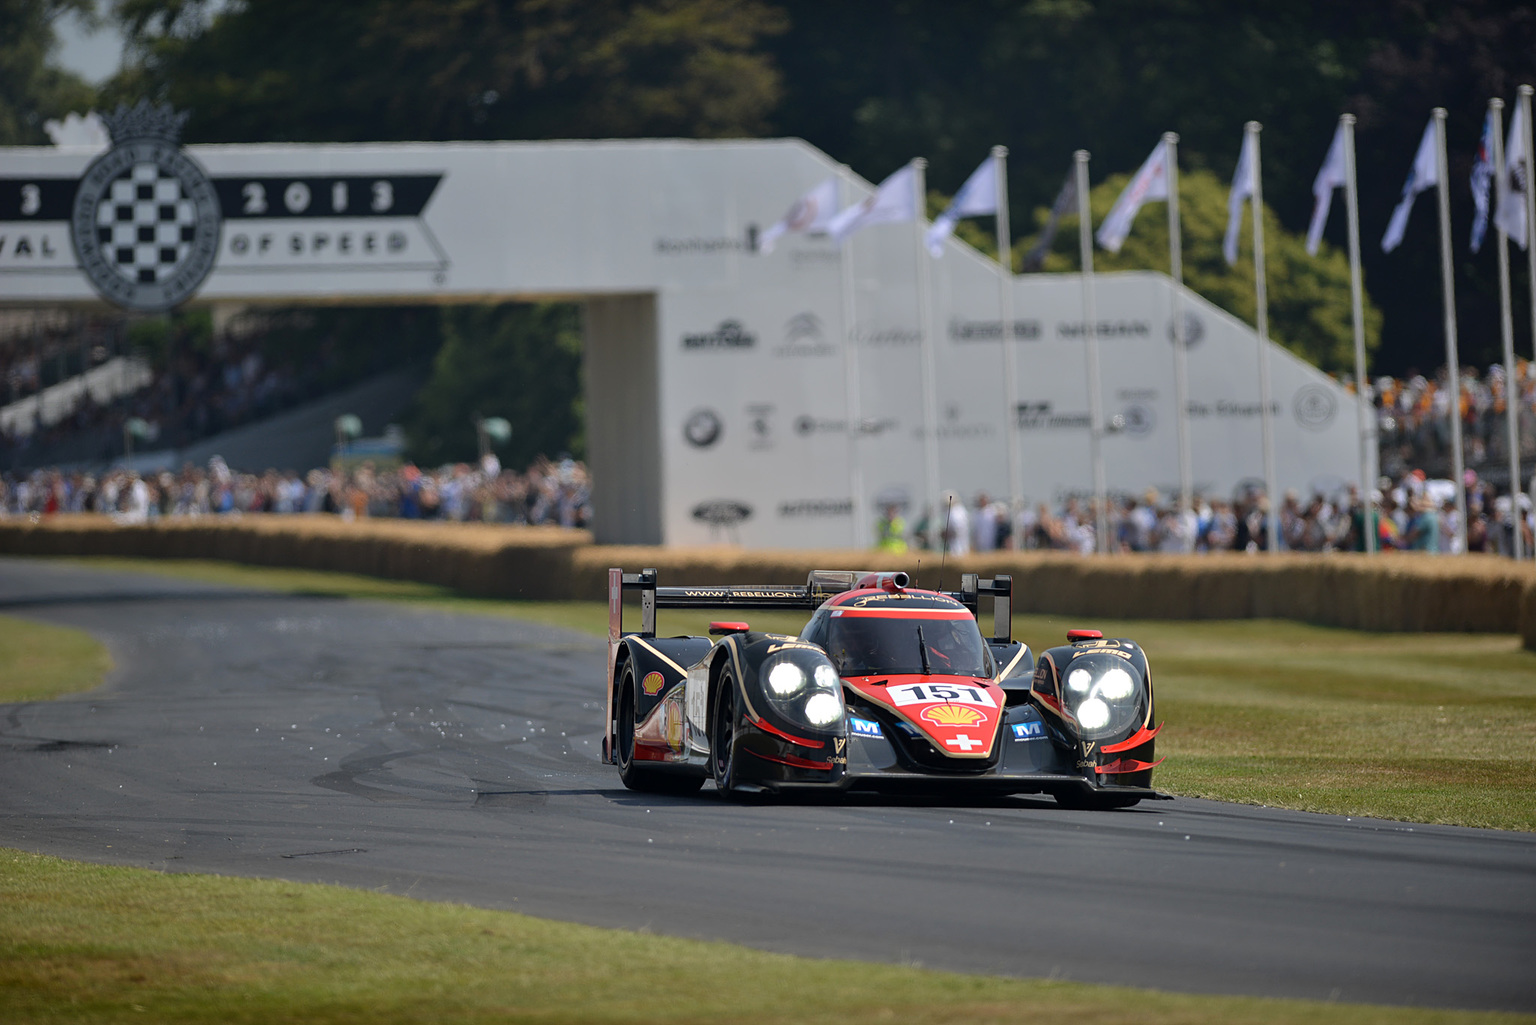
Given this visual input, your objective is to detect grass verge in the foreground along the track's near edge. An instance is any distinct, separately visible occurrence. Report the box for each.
[0,848,1536,1025]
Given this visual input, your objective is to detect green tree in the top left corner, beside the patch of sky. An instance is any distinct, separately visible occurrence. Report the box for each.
[0,0,95,146]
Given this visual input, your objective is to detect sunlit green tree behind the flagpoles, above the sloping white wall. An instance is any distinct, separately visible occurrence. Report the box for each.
[1015,171,1381,375]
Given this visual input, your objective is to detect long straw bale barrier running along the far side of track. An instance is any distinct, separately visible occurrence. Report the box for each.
[9,515,1536,650]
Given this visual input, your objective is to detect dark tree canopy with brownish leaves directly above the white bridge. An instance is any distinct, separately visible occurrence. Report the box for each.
[112,0,785,141]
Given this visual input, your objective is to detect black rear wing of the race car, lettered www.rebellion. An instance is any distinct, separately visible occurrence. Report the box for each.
[608,569,1014,644]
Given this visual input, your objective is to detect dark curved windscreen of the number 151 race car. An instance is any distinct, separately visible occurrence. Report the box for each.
[826,616,992,676]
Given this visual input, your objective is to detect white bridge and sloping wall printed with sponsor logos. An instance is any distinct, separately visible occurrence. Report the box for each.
[0,140,1358,547]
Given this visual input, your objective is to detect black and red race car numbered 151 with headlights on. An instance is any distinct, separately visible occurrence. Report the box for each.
[602,569,1163,808]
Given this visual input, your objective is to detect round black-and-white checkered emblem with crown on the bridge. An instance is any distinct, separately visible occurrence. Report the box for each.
[69,103,223,312]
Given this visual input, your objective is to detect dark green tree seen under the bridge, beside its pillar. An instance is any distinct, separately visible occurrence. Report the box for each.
[404,303,582,467]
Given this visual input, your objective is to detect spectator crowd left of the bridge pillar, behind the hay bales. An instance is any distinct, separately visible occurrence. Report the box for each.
[0,456,591,527]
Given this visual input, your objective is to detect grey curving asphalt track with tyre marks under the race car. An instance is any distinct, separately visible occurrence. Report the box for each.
[0,559,1536,1011]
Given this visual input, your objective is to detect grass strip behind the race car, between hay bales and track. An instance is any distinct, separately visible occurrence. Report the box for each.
[38,559,1536,830]
